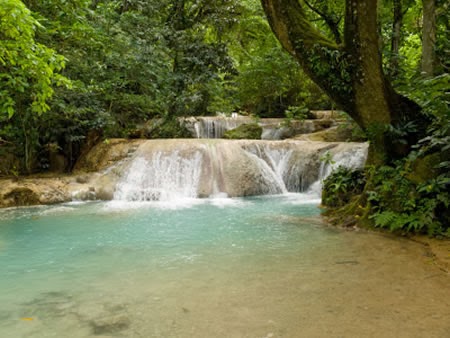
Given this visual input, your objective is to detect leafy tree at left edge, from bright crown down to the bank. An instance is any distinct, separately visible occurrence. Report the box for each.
[0,0,70,172]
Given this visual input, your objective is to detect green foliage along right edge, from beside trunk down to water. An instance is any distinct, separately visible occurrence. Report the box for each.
[369,74,450,236]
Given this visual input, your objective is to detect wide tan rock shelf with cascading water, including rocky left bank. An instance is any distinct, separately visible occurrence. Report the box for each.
[0,139,367,207]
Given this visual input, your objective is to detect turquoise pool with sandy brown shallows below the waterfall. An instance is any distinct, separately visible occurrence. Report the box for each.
[0,194,450,337]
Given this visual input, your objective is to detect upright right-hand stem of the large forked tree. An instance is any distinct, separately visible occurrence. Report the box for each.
[344,0,392,164]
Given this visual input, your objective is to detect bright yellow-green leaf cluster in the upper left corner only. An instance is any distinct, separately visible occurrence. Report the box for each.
[0,0,69,118]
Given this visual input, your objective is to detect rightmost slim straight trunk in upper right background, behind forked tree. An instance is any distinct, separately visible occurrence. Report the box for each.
[422,0,436,76]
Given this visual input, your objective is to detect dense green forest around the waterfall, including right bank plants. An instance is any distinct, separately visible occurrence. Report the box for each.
[0,0,450,236]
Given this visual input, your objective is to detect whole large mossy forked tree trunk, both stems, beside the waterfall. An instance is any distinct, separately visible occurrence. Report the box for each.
[261,0,426,164]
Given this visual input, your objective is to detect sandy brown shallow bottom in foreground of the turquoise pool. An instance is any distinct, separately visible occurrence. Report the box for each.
[0,199,450,338]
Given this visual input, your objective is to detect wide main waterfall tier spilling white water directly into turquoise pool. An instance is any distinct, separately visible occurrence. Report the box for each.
[114,139,367,201]
